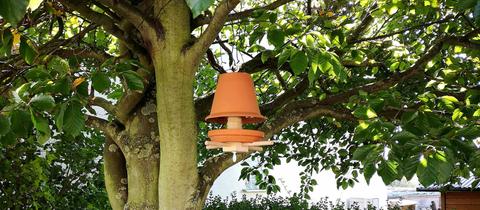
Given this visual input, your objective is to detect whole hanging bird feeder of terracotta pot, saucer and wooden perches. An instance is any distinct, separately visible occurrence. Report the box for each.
[205,72,273,159]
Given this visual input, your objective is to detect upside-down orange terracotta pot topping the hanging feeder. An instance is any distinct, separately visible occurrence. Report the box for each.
[205,72,266,124]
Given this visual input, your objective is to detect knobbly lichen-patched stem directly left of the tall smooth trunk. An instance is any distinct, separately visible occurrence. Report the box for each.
[122,96,160,209]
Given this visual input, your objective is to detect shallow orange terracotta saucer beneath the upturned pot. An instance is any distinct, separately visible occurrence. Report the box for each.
[208,129,265,143]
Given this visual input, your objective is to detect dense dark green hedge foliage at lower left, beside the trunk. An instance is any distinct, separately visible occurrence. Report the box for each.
[0,132,110,209]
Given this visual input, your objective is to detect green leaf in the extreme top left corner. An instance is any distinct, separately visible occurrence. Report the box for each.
[0,0,28,26]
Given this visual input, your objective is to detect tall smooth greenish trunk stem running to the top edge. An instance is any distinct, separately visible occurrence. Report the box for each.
[147,1,203,209]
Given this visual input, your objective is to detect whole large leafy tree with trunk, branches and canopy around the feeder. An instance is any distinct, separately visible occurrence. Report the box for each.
[0,0,480,209]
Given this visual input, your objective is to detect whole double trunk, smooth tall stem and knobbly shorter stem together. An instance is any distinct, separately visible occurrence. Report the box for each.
[105,0,218,210]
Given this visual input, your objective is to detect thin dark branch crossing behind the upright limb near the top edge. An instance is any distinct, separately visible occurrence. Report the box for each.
[194,0,293,27]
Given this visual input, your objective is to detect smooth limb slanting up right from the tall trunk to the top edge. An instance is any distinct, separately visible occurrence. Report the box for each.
[187,0,240,62]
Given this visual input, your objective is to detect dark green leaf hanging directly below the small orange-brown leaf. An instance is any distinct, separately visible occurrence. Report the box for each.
[63,102,85,137]
